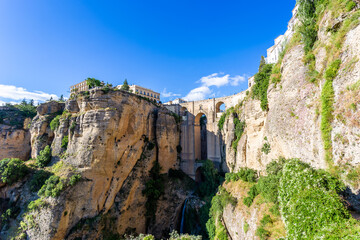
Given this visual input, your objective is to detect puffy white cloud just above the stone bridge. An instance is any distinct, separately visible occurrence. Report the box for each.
[184,73,246,101]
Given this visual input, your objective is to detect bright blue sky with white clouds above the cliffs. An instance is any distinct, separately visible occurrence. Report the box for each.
[0,0,295,103]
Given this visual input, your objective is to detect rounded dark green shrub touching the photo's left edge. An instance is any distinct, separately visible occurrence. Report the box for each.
[0,158,28,185]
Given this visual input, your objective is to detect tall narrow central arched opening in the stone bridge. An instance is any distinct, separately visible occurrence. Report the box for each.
[194,113,207,160]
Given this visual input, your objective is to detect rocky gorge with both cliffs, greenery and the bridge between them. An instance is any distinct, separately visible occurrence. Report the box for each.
[0,0,360,239]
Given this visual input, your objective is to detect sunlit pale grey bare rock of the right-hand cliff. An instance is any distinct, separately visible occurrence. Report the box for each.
[222,2,360,239]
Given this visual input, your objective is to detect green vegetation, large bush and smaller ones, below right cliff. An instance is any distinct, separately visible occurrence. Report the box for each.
[224,158,360,239]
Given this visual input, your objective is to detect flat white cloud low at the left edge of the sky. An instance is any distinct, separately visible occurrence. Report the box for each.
[0,84,58,103]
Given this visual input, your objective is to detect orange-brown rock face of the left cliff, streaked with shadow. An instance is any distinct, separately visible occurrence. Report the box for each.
[1,90,188,239]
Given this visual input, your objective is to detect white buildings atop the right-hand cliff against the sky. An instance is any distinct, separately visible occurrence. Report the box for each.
[265,5,299,64]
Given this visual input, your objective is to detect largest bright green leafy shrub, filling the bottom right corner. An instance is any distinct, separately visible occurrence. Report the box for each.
[279,159,360,239]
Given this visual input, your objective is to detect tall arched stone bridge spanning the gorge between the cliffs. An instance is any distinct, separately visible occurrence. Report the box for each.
[165,91,246,179]
